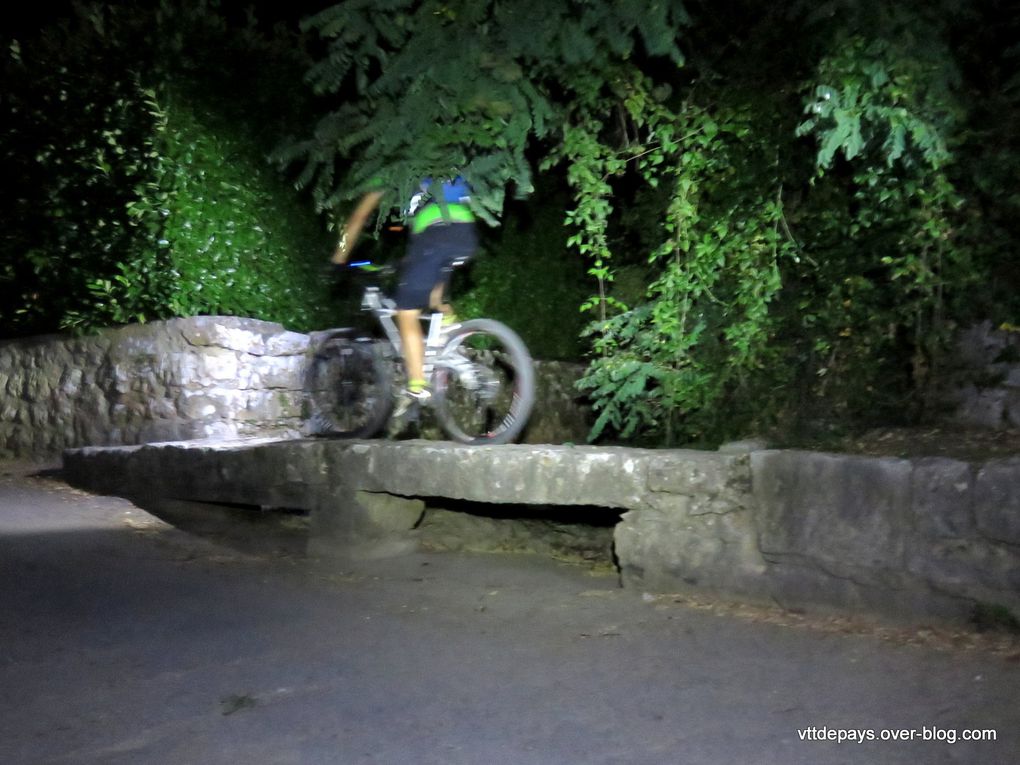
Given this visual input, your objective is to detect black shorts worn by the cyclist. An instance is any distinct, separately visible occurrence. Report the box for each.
[395,223,478,310]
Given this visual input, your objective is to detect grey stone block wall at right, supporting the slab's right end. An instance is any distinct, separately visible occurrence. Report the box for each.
[616,450,1020,620]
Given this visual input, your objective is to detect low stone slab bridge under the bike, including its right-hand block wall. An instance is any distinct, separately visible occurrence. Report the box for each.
[64,440,1020,620]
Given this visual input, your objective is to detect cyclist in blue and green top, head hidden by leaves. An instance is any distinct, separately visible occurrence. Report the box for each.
[332,176,478,415]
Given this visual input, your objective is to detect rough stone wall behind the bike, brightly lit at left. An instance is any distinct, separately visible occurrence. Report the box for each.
[0,316,590,459]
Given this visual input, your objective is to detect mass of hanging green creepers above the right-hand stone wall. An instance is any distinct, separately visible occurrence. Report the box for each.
[564,0,1007,444]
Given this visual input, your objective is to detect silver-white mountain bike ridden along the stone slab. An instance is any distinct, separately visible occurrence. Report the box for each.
[305,261,534,445]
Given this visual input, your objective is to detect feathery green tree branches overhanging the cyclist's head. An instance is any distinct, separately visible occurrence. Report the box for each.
[279,0,685,222]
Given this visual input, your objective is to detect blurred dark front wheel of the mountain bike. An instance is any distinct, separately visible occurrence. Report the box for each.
[305,338,393,439]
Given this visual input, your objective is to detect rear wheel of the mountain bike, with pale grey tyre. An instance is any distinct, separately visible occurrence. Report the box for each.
[432,319,534,446]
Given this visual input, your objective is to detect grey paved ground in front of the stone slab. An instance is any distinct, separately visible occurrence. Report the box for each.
[0,470,1020,765]
